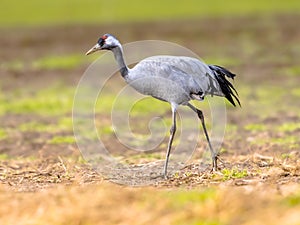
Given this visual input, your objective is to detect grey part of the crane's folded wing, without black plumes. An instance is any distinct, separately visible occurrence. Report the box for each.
[135,56,220,96]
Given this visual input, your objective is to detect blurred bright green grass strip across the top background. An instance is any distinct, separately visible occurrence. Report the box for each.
[0,0,300,27]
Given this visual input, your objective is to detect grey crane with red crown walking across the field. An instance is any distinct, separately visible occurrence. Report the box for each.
[86,34,240,177]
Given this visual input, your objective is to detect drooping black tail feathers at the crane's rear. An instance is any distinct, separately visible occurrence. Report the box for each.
[208,65,241,106]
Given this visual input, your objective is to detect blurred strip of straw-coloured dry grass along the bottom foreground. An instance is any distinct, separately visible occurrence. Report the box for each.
[0,182,300,224]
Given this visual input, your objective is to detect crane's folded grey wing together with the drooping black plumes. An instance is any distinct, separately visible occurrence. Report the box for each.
[133,56,239,105]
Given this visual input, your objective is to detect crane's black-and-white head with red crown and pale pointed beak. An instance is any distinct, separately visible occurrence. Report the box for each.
[86,34,121,55]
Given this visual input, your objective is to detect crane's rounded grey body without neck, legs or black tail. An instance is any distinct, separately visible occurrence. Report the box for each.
[127,56,223,104]
